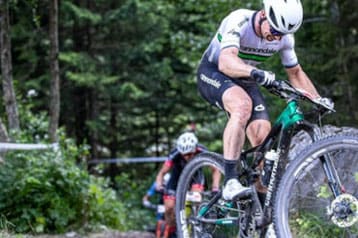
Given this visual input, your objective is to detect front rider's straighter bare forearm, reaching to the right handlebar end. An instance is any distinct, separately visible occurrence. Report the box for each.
[286,64,320,99]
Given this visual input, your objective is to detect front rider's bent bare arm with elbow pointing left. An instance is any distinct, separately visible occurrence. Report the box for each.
[218,46,255,78]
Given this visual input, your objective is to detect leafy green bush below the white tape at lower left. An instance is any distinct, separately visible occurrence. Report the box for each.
[0,138,125,233]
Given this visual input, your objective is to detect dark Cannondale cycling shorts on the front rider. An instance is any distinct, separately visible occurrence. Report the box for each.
[197,56,269,121]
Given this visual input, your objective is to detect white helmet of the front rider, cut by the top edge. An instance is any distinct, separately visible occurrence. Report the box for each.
[263,0,303,34]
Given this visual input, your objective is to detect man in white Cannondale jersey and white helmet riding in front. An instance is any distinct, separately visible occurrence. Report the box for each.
[197,0,328,200]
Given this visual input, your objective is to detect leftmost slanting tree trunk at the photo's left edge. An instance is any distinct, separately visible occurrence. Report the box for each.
[0,0,20,134]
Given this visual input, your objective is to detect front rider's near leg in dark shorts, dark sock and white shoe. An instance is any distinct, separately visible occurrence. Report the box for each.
[198,59,252,200]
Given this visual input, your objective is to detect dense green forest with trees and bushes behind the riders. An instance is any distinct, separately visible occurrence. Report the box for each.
[0,0,358,233]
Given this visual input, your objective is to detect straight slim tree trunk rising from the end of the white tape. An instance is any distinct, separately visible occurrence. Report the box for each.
[49,0,60,142]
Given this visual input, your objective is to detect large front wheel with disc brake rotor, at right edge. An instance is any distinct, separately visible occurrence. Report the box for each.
[274,135,358,238]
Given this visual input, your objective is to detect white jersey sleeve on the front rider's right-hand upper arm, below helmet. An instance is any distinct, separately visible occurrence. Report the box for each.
[280,35,298,68]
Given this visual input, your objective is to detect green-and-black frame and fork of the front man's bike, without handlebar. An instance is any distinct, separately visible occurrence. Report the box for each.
[197,98,339,227]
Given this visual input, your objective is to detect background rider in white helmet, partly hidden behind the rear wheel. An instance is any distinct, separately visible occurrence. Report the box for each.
[156,132,219,238]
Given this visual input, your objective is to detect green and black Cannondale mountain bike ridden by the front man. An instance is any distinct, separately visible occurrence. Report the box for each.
[176,80,358,238]
